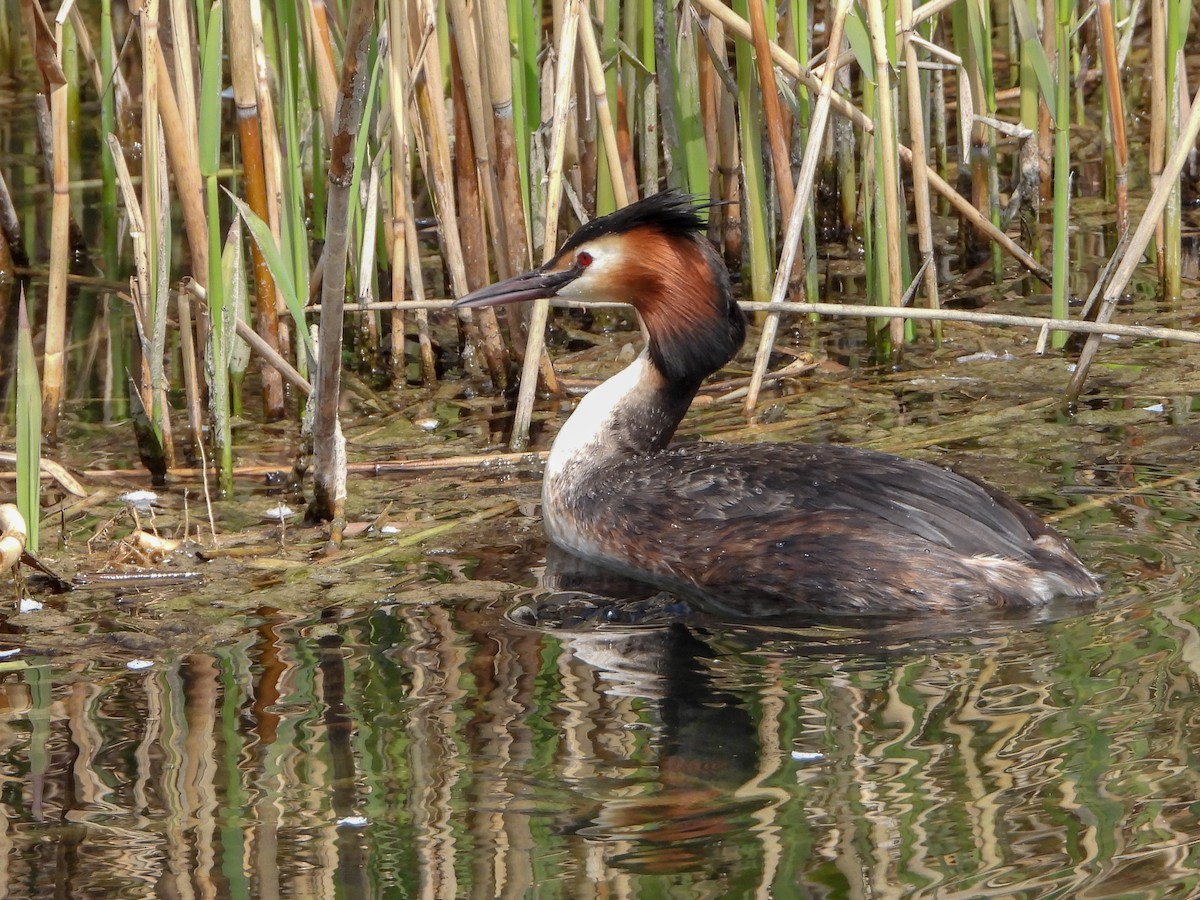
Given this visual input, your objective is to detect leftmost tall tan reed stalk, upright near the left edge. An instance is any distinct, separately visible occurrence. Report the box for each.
[42,15,71,444]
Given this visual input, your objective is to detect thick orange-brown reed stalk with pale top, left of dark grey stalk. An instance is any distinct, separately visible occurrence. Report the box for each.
[229,0,287,421]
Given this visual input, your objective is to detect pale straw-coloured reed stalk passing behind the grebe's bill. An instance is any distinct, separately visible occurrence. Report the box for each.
[510,0,587,451]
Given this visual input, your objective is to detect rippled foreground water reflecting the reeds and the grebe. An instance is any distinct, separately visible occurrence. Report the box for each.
[0,559,1200,898]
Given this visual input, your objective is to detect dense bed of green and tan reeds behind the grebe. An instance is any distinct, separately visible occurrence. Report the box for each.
[0,0,1200,541]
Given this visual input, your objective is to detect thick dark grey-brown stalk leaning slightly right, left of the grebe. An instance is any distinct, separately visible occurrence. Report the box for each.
[307,0,374,528]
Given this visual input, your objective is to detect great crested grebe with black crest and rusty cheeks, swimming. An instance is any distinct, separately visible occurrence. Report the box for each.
[455,192,1099,617]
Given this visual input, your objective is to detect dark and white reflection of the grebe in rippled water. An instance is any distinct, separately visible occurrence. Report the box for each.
[511,547,772,872]
